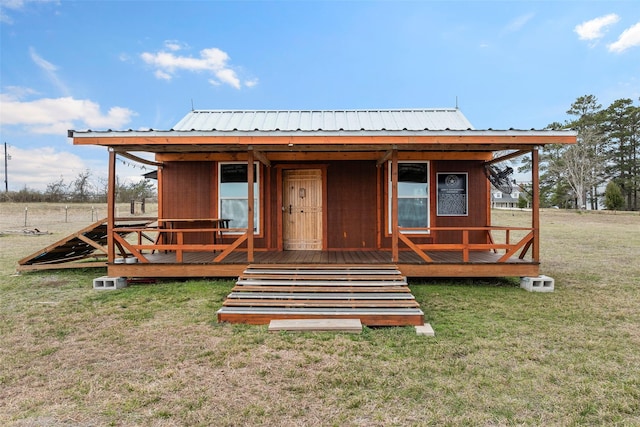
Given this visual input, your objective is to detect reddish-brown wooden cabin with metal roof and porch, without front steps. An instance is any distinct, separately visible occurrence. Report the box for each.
[68,109,576,277]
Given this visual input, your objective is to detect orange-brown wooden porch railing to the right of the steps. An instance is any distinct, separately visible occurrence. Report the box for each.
[398,226,537,263]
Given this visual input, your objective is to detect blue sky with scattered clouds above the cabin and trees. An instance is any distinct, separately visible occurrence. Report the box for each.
[0,0,640,190]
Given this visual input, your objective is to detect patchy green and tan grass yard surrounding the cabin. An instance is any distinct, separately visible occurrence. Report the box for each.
[0,204,640,426]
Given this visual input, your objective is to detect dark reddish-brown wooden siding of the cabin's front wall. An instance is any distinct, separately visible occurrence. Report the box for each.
[160,160,496,250]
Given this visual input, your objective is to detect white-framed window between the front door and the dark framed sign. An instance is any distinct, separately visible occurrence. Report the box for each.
[389,162,429,234]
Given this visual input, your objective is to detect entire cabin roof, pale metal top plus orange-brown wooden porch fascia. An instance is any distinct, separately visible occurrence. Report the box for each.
[68,109,576,153]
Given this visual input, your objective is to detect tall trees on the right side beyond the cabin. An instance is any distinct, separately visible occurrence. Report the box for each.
[520,95,640,211]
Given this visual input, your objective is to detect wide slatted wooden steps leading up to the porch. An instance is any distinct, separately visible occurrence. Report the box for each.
[218,264,424,326]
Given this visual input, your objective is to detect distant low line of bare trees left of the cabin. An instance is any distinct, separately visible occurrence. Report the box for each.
[0,169,157,203]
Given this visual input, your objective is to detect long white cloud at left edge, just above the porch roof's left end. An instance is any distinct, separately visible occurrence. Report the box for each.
[0,90,136,135]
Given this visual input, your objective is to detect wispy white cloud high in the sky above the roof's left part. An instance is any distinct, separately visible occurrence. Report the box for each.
[140,40,252,89]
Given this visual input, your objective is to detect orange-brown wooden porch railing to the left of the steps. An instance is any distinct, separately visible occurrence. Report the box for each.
[110,218,248,263]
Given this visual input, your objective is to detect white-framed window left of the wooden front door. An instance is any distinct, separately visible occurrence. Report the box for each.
[218,163,260,233]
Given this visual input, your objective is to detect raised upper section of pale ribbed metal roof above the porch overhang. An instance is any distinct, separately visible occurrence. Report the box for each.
[172,108,473,132]
